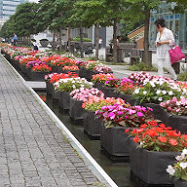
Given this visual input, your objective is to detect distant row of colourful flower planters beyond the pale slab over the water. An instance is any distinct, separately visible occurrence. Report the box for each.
[1,45,112,81]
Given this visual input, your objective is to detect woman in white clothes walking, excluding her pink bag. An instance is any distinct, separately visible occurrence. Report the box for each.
[155,19,177,80]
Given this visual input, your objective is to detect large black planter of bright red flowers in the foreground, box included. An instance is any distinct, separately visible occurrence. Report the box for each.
[126,121,187,185]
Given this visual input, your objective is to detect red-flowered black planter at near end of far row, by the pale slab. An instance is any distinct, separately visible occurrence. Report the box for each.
[31,64,51,81]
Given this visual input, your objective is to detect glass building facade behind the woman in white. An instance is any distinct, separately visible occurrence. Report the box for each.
[149,4,187,51]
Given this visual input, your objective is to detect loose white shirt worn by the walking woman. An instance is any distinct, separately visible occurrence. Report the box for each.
[155,28,175,59]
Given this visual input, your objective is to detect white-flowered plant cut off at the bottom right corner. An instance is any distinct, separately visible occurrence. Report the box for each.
[166,148,187,187]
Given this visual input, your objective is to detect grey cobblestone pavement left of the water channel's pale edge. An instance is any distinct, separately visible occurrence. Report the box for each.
[0,55,108,187]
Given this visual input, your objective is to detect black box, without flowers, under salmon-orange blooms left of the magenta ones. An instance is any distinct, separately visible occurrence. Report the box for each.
[83,111,102,139]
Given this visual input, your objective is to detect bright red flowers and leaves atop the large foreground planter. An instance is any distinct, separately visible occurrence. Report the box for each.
[125,121,187,152]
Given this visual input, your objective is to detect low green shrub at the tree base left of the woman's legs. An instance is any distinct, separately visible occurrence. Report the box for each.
[128,62,157,71]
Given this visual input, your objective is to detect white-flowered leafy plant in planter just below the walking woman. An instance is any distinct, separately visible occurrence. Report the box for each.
[133,77,186,119]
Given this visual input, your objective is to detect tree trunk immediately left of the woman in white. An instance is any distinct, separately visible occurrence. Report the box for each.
[144,9,151,65]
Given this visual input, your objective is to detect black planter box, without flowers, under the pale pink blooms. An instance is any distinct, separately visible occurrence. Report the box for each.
[69,97,85,120]
